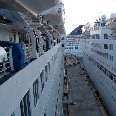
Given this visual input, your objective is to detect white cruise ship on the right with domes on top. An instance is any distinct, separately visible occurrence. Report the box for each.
[77,13,116,116]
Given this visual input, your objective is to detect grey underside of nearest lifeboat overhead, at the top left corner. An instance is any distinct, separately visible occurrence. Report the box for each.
[0,0,61,16]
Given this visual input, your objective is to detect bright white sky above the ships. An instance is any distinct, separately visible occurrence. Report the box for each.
[62,0,116,34]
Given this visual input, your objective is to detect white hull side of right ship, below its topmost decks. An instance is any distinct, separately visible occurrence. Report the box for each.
[79,39,116,116]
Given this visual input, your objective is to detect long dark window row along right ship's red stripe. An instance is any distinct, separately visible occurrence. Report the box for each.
[89,57,116,83]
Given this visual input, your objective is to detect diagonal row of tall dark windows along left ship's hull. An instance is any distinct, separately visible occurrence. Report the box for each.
[11,63,50,116]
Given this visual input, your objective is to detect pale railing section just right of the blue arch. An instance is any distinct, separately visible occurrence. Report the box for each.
[24,44,32,62]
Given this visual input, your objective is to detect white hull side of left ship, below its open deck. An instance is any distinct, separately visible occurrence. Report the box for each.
[0,44,64,116]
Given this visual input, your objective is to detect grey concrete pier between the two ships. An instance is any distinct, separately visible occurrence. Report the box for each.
[66,59,107,116]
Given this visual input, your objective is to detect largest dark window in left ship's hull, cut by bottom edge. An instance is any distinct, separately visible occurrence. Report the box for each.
[20,90,31,116]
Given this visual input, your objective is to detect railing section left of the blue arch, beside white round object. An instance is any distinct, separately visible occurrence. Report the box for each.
[0,46,14,78]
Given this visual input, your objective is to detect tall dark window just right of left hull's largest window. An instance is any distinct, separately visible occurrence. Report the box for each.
[33,79,39,107]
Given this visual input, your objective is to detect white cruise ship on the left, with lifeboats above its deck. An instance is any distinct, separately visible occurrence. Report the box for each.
[0,0,66,116]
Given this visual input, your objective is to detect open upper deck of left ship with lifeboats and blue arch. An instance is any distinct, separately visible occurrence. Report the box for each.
[0,0,65,84]
